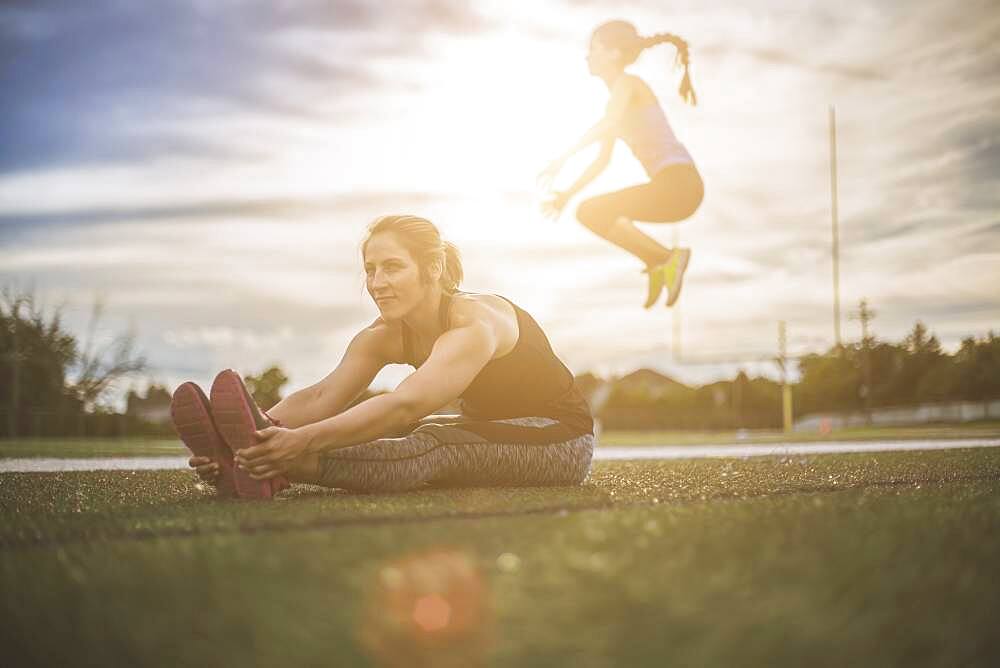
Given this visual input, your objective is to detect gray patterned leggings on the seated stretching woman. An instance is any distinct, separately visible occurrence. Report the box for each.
[318,416,594,492]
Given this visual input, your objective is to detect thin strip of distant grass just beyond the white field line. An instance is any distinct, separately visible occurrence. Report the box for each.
[0,421,1000,458]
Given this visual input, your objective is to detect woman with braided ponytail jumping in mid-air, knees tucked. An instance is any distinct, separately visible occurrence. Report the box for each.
[540,21,704,308]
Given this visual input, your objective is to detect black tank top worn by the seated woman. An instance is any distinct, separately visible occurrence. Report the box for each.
[402,294,594,434]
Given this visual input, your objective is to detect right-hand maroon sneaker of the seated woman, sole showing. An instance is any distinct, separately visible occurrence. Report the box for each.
[211,369,289,499]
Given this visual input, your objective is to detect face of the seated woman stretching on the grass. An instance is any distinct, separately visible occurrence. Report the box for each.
[364,232,430,320]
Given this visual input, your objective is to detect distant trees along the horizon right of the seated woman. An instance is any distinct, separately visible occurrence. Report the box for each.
[578,322,1000,429]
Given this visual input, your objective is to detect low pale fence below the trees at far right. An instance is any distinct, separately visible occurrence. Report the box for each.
[794,399,1000,432]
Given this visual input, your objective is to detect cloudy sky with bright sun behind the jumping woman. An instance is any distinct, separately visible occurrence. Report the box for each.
[0,0,1000,402]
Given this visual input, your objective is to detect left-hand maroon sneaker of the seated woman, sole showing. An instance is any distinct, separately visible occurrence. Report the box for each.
[170,382,236,497]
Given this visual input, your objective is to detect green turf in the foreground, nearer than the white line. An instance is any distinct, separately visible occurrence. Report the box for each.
[0,448,1000,667]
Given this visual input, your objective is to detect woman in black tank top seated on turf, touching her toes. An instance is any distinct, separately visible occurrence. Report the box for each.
[172,216,594,498]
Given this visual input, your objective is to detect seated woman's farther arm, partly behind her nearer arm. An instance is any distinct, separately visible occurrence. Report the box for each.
[268,321,389,428]
